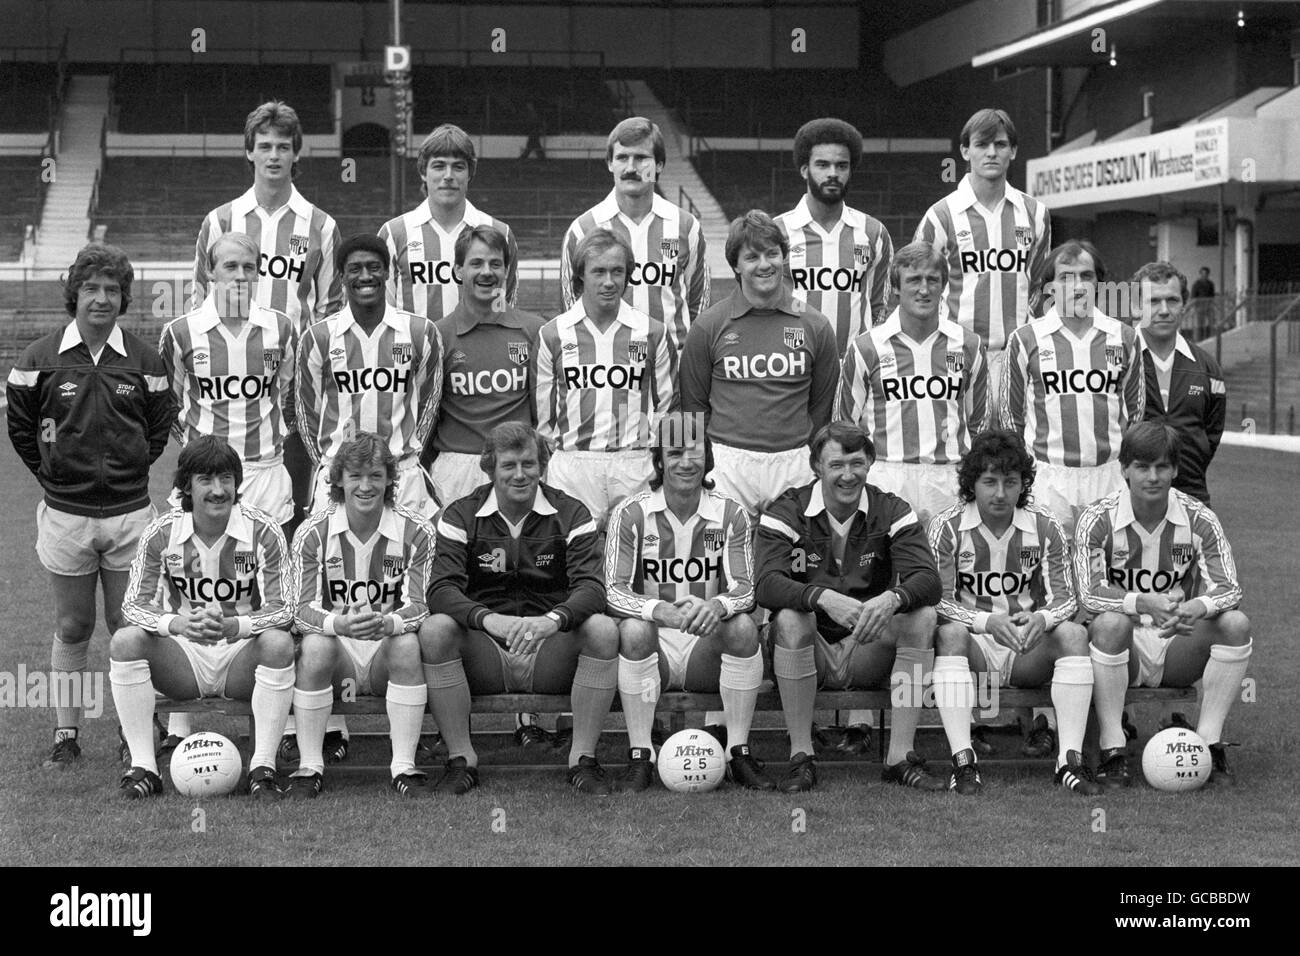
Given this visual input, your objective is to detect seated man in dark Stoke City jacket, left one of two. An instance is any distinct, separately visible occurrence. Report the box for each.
[420,421,619,795]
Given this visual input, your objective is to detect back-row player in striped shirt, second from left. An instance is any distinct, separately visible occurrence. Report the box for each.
[380,124,519,321]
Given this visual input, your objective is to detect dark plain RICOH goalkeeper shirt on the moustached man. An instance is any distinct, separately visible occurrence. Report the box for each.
[432,304,542,455]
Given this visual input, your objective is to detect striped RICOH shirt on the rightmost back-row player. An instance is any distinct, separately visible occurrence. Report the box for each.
[913,174,1052,351]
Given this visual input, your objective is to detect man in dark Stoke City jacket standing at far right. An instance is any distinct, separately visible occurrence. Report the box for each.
[1131,263,1227,505]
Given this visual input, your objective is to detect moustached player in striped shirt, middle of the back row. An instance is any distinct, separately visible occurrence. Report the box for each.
[560,116,709,359]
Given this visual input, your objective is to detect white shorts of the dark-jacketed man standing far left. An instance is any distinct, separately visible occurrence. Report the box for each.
[36,501,157,578]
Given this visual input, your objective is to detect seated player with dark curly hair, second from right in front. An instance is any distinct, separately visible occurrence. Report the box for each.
[930,431,1102,796]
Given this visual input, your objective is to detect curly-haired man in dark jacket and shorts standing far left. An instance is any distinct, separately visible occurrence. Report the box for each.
[5,243,176,770]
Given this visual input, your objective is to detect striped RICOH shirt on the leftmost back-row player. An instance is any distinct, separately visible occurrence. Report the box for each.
[191,187,343,334]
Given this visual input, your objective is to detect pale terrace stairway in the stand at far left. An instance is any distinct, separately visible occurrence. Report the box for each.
[35,75,109,269]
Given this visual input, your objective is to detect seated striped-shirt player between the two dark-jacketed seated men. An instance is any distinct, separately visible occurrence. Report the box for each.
[605,416,776,791]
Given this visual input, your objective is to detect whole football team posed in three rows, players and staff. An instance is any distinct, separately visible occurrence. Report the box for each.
[8,101,1251,799]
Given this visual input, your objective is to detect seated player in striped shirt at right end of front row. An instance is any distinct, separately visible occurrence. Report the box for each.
[1074,421,1252,787]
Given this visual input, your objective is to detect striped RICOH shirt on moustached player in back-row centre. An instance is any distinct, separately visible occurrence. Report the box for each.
[560,191,709,362]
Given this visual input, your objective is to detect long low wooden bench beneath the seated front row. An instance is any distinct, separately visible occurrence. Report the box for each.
[155,680,1197,762]
